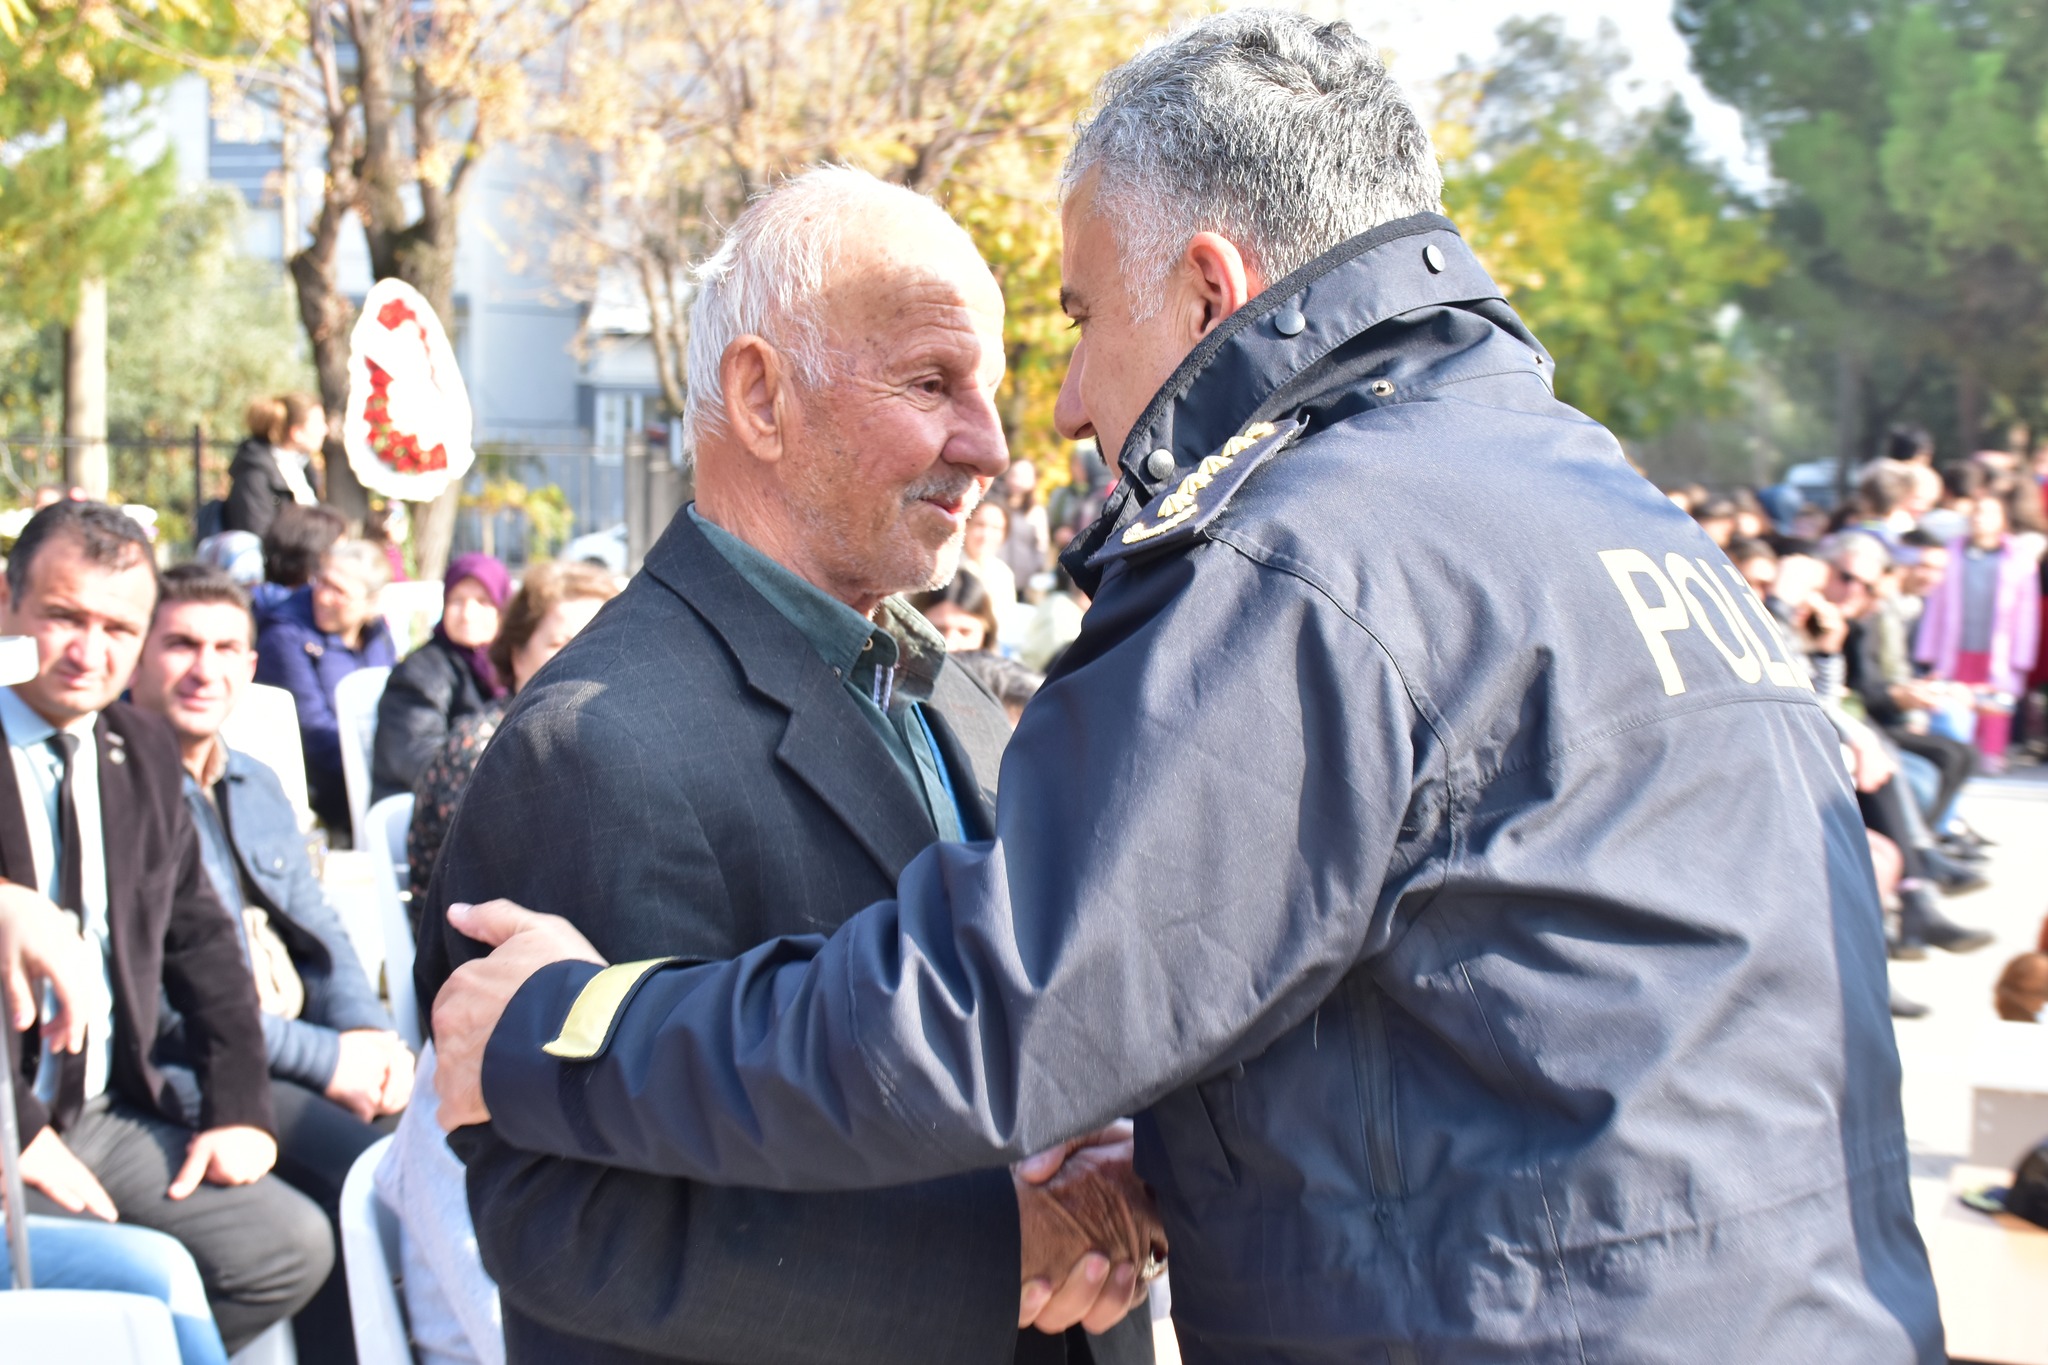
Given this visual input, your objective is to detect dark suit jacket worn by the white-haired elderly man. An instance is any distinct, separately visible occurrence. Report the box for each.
[418,516,1151,1365]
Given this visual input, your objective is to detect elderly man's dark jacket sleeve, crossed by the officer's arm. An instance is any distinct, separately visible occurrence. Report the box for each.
[430,699,1020,1365]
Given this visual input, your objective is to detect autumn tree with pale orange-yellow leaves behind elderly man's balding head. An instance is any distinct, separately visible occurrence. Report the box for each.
[545,0,1174,474]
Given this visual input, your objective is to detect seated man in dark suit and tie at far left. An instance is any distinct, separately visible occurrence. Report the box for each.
[0,501,334,1351]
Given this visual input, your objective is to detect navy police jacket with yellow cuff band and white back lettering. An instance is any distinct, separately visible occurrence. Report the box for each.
[483,217,1942,1365]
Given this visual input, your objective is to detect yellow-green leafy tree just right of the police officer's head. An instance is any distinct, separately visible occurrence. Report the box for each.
[1438,16,1782,438]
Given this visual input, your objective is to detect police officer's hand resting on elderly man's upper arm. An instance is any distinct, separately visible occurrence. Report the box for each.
[434,900,604,1132]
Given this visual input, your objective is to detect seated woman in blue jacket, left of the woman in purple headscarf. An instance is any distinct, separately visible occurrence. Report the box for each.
[256,540,397,833]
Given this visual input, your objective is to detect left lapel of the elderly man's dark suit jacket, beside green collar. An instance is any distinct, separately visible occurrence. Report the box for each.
[645,512,936,880]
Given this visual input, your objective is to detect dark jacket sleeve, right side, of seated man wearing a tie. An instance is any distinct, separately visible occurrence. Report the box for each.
[164,806,276,1134]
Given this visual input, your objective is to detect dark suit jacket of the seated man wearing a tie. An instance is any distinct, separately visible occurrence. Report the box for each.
[0,702,276,1146]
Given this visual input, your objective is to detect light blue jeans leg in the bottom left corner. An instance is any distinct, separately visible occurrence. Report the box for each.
[0,1214,227,1365]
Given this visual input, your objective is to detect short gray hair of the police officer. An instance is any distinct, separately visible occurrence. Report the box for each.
[1061,10,1444,321]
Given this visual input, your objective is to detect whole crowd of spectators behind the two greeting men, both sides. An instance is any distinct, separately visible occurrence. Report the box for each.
[0,376,2048,1365]
